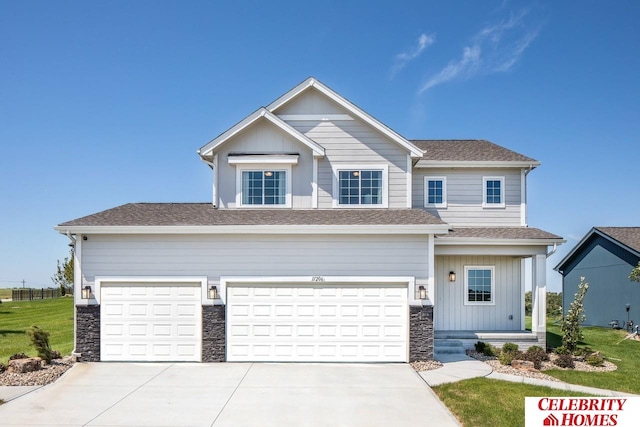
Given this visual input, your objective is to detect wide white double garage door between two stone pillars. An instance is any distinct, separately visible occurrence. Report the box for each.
[227,284,408,362]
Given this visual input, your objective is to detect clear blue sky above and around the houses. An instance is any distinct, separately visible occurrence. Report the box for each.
[0,0,640,291]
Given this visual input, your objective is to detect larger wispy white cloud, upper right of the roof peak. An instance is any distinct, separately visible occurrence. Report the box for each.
[418,10,540,94]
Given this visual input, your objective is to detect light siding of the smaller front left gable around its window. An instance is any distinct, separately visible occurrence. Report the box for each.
[218,119,313,209]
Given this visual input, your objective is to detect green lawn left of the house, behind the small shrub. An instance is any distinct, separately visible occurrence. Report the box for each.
[0,298,73,364]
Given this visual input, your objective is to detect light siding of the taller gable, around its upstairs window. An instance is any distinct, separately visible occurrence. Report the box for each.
[275,89,411,208]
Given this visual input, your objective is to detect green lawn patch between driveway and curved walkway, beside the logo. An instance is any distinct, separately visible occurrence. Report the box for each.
[433,378,588,427]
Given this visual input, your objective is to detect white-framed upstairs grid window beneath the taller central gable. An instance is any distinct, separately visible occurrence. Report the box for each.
[334,166,387,207]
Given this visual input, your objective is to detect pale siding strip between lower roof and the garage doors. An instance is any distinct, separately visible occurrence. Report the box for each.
[82,235,429,286]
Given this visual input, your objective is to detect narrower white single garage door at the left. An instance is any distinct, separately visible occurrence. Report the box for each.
[100,282,202,361]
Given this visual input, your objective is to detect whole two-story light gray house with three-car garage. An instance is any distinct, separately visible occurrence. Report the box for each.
[56,78,564,362]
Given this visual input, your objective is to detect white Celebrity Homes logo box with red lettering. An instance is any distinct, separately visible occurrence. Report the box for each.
[525,396,640,427]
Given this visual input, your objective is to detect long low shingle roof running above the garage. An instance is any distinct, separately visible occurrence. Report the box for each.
[59,203,445,227]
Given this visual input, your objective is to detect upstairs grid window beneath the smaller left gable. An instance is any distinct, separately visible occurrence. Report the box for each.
[242,170,287,206]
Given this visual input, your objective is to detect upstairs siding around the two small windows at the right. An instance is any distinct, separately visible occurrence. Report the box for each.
[412,169,522,226]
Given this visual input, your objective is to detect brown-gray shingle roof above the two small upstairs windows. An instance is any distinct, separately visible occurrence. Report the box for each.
[411,139,538,163]
